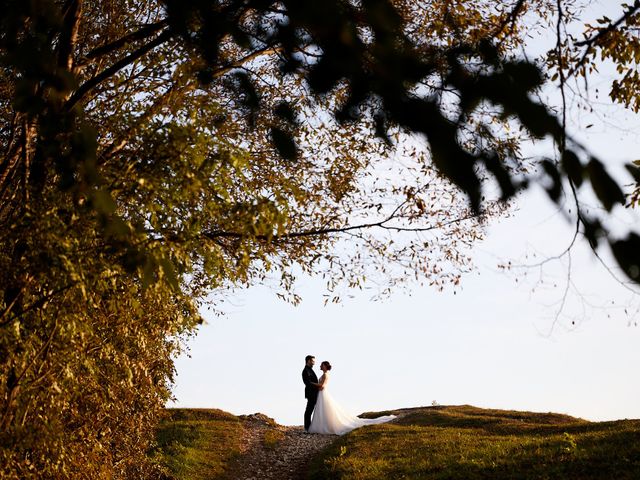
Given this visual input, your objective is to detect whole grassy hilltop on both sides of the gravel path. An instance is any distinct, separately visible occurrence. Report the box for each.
[152,405,640,480]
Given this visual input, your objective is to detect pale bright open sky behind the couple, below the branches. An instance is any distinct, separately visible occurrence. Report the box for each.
[169,2,640,425]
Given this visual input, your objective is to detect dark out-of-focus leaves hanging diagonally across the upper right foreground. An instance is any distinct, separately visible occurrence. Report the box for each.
[169,0,640,281]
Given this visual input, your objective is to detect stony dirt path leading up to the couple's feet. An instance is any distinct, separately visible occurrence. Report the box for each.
[227,414,338,480]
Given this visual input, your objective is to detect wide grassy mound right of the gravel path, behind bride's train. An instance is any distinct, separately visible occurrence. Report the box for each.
[310,405,640,480]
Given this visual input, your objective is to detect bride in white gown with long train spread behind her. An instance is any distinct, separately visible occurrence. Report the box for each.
[309,361,396,435]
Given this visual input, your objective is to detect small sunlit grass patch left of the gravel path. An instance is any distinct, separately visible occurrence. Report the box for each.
[151,409,242,480]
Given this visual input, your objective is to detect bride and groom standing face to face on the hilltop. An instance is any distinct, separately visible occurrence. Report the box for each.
[302,355,395,435]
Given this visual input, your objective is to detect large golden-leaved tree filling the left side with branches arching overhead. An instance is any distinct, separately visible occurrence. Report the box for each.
[0,0,635,478]
